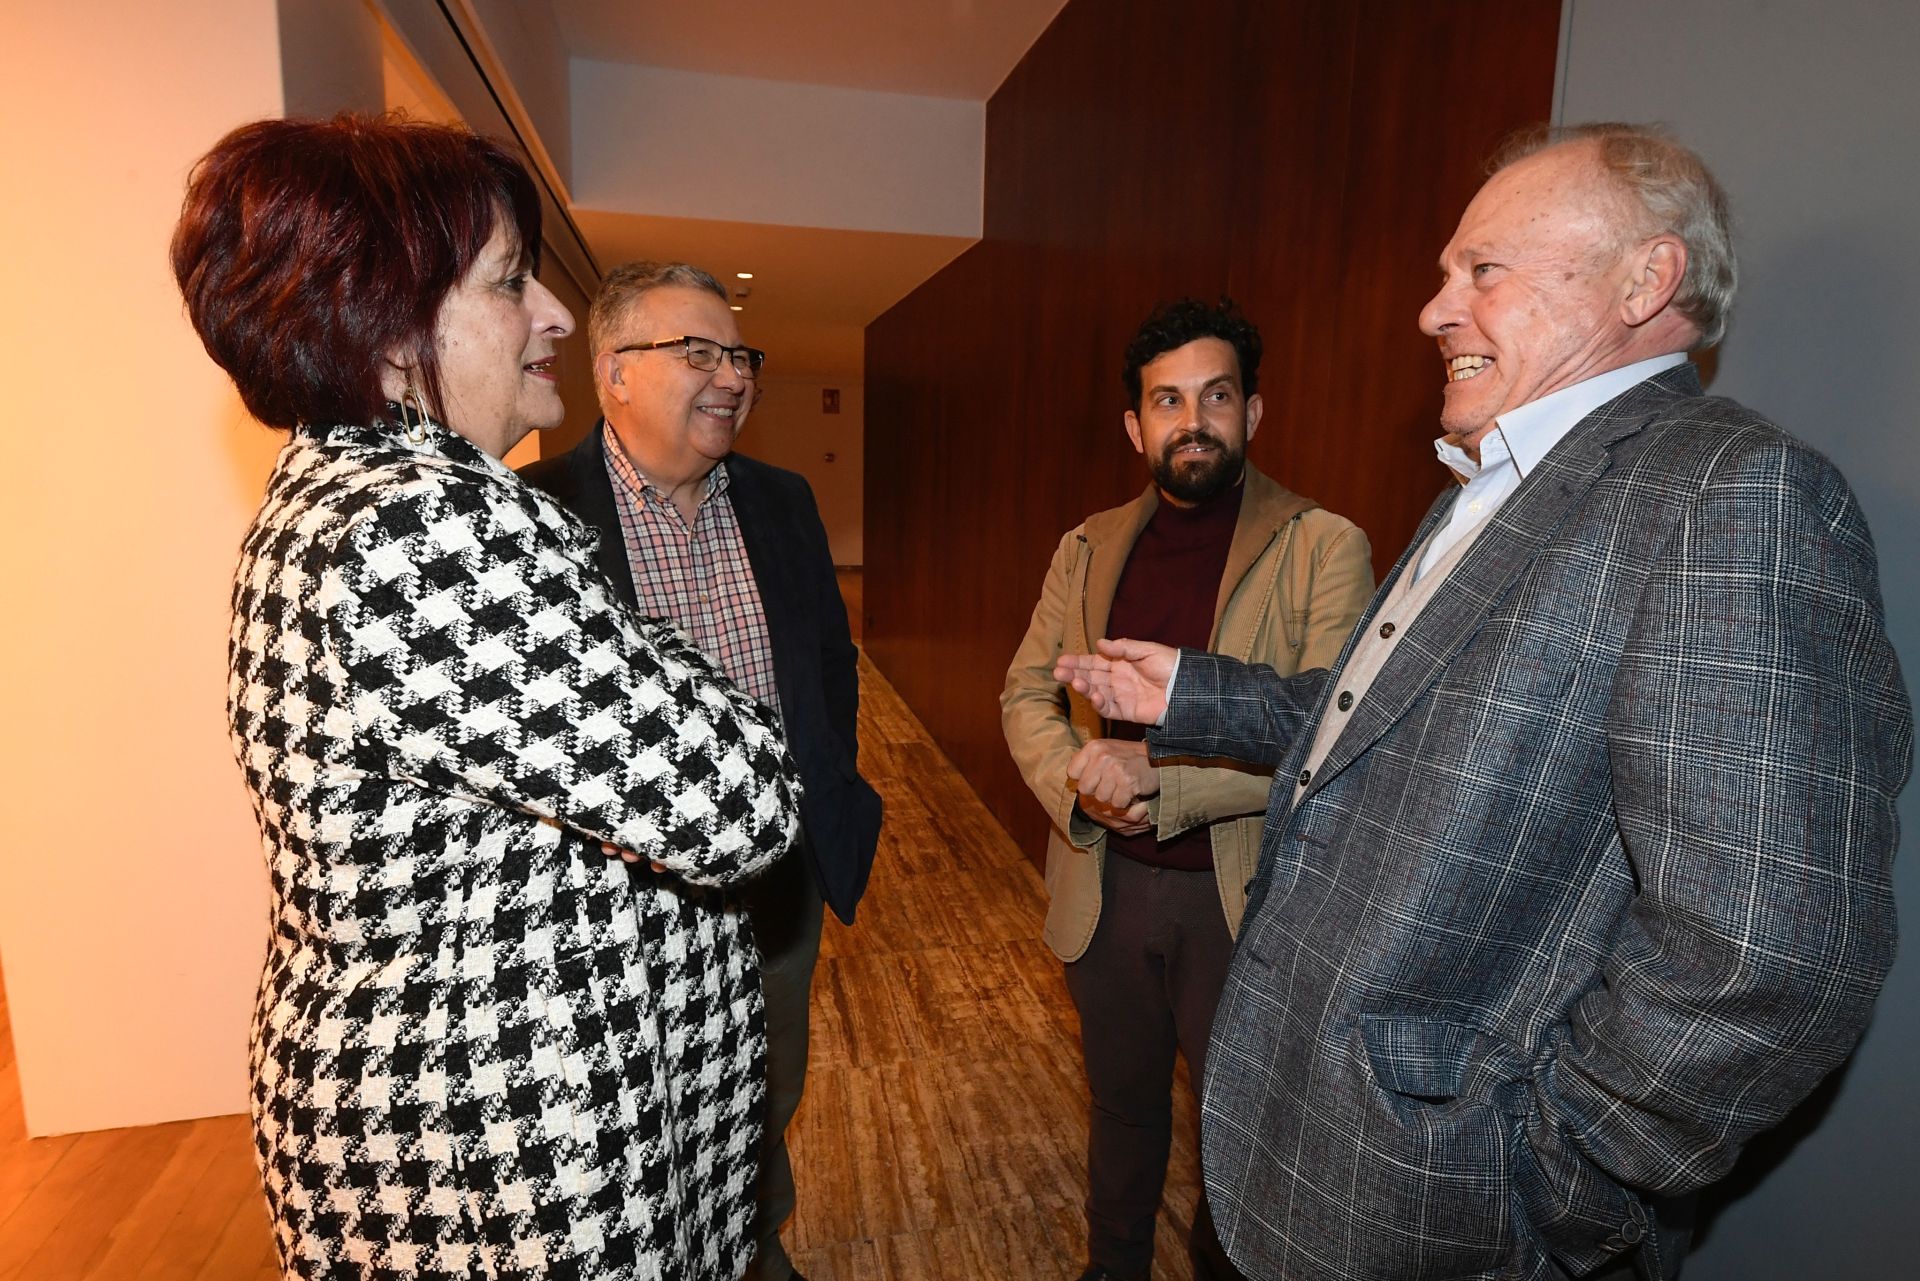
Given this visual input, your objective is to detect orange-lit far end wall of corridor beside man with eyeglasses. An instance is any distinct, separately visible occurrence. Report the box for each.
[739,378,866,565]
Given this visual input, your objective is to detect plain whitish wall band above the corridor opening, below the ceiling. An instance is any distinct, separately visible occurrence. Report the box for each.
[572,59,987,238]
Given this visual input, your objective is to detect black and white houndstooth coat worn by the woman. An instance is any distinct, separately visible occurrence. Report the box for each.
[228,416,799,1281]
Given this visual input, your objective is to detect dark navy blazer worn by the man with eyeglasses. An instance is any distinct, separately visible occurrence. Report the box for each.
[520,421,879,926]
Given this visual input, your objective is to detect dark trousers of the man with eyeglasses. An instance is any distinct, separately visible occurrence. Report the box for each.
[741,849,822,1281]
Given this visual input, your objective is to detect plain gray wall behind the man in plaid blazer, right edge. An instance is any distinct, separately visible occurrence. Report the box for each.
[1561,0,1920,1281]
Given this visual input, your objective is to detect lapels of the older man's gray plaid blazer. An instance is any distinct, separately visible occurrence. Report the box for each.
[1309,365,1699,795]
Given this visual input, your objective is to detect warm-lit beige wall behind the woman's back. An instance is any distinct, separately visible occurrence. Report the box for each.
[0,0,280,1133]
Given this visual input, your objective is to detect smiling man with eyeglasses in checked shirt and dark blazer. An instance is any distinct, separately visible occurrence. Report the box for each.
[524,263,879,1281]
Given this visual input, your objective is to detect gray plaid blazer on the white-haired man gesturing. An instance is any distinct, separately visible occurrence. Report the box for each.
[1150,365,1912,1281]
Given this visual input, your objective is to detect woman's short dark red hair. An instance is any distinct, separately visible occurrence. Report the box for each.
[171,115,540,428]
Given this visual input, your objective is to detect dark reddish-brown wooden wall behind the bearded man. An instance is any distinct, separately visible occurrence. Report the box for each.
[866,0,1559,871]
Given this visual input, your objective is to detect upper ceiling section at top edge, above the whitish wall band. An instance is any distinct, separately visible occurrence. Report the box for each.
[549,0,1066,102]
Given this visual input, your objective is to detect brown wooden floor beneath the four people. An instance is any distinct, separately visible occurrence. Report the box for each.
[0,633,1196,1281]
